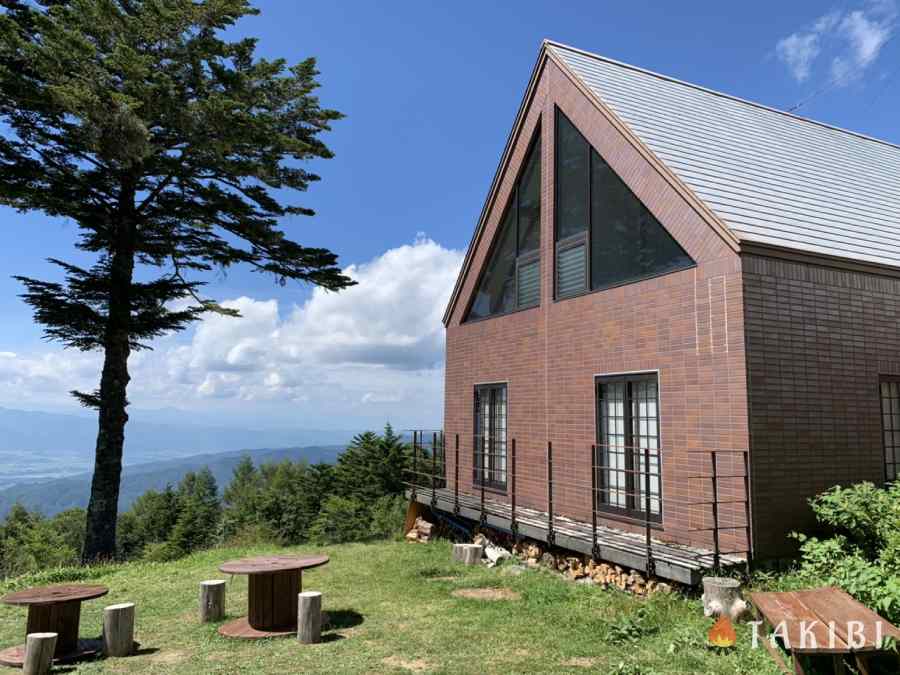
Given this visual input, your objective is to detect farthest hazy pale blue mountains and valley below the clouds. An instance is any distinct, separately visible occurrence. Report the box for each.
[0,408,355,489]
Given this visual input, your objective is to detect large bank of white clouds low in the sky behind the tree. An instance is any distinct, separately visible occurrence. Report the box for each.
[0,236,462,426]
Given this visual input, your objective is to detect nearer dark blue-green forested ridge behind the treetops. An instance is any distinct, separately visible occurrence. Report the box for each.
[0,445,344,517]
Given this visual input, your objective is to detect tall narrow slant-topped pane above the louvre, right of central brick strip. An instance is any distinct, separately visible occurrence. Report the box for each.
[556,113,590,239]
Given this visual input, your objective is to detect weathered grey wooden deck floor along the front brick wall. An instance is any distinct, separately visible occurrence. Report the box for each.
[410,487,746,586]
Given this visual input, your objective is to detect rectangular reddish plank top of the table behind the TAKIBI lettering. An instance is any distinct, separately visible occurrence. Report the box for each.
[750,586,900,654]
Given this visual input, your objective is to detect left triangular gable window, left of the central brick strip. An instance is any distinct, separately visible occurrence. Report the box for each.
[467,135,541,319]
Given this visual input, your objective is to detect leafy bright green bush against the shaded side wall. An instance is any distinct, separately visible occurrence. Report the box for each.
[793,483,900,623]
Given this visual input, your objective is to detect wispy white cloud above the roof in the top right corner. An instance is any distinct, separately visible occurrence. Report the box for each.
[775,0,898,86]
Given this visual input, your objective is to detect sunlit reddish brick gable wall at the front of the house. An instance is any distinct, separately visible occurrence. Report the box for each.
[444,62,748,560]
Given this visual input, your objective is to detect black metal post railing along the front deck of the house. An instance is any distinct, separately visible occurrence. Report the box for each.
[408,430,753,572]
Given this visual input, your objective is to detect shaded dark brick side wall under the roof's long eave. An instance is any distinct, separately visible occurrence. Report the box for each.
[744,256,900,555]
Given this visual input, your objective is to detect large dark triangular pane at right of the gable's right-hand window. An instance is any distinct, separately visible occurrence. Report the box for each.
[591,149,693,288]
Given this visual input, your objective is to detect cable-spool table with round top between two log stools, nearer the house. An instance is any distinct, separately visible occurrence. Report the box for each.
[219,555,328,639]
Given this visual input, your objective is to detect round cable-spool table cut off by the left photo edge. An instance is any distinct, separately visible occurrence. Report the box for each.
[0,584,109,668]
